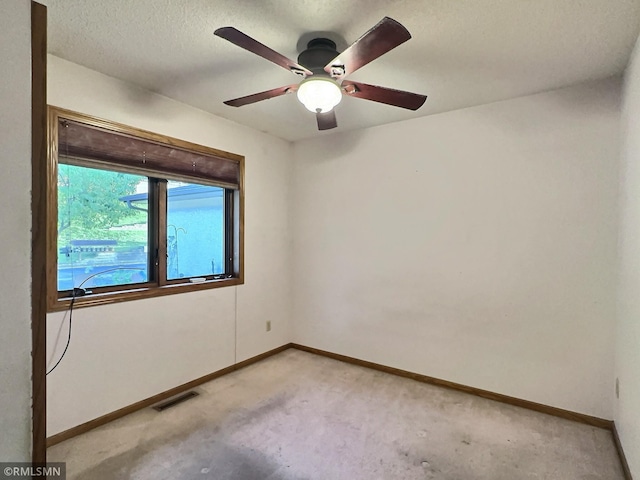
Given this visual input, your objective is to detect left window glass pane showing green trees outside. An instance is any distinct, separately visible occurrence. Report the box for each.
[58,163,149,291]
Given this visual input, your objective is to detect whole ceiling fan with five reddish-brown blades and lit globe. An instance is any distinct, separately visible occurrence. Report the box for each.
[214,17,427,130]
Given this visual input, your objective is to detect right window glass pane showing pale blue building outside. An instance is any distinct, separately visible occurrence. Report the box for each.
[167,181,224,280]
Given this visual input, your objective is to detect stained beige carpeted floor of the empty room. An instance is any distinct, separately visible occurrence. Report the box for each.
[48,349,624,480]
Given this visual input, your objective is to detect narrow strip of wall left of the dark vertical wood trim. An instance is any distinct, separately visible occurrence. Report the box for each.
[0,0,31,461]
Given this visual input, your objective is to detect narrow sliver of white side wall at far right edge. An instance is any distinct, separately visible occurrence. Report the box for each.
[615,32,640,477]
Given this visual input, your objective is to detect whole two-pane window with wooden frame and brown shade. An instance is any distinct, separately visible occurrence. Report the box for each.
[47,107,244,310]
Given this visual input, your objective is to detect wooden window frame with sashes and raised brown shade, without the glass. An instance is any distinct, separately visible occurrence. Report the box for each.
[46,106,244,311]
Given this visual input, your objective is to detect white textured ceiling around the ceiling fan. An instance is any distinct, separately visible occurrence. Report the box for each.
[40,0,640,140]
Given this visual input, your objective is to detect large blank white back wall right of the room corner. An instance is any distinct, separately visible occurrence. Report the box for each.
[293,79,620,419]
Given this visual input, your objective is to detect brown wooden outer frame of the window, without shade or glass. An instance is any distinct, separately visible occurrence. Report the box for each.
[46,106,244,312]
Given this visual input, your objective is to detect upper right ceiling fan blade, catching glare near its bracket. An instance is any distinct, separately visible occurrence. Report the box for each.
[324,17,411,80]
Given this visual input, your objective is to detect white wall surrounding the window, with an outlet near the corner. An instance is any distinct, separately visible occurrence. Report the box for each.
[47,56,292,436]
